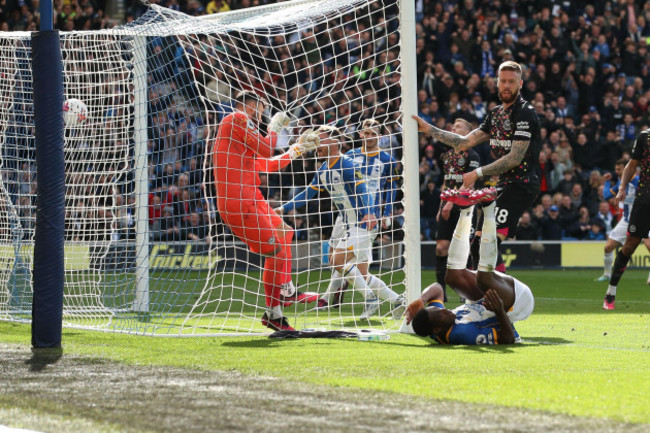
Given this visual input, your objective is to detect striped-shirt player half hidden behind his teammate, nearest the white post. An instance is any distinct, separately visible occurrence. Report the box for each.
[318,119,406,319]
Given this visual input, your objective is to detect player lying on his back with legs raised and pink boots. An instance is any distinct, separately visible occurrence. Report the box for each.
[406,188,535,345]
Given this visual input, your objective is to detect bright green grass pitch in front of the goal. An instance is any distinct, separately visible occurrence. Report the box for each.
[0,269,650,423]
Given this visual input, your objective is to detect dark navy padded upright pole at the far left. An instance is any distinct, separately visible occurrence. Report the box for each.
[31,25,65,349]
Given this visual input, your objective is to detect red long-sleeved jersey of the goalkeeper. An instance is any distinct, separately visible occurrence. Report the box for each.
[213,111,290,208]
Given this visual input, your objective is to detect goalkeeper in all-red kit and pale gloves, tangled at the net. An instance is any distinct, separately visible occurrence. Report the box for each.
[213,91,318,330]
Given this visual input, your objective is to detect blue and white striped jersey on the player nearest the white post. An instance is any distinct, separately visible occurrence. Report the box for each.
[346,148,399,218]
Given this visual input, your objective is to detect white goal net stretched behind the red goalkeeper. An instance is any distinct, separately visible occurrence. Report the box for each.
[0,0,419,335]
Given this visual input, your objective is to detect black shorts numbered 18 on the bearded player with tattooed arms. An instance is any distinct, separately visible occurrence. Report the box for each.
[477,183,539,239]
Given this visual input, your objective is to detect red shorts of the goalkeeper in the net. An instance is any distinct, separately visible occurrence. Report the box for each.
[217,200,282,256]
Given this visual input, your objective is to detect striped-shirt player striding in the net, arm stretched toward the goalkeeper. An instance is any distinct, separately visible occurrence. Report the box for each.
[276,126,404,318]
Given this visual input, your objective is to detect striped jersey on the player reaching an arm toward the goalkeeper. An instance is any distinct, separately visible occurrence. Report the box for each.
[282,155,377,228]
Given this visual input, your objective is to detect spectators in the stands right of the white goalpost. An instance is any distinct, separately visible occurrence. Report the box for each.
[416,0,650,240]
